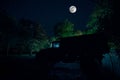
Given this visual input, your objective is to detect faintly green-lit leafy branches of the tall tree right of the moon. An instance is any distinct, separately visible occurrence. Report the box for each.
[87,0,113,33]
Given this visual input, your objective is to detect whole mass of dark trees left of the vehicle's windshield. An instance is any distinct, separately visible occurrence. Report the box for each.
[0,10,49,54]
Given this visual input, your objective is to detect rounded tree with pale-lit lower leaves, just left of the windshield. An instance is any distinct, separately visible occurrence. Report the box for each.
[19,19,49,54]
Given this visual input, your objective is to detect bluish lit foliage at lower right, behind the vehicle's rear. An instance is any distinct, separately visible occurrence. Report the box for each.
[102,48,120,75]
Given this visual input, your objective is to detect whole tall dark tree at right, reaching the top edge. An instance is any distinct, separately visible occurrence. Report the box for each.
[87,0,120,53]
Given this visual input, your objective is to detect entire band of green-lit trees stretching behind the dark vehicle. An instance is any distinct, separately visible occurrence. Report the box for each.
[0,0,120,54]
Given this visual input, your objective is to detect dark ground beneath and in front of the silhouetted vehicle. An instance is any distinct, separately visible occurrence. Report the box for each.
[0,56,120,80]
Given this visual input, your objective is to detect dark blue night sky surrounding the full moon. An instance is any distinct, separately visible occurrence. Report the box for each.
[0,0,94,35]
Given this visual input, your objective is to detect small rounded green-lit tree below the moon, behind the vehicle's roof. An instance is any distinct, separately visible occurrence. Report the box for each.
[54,20,74,38]
